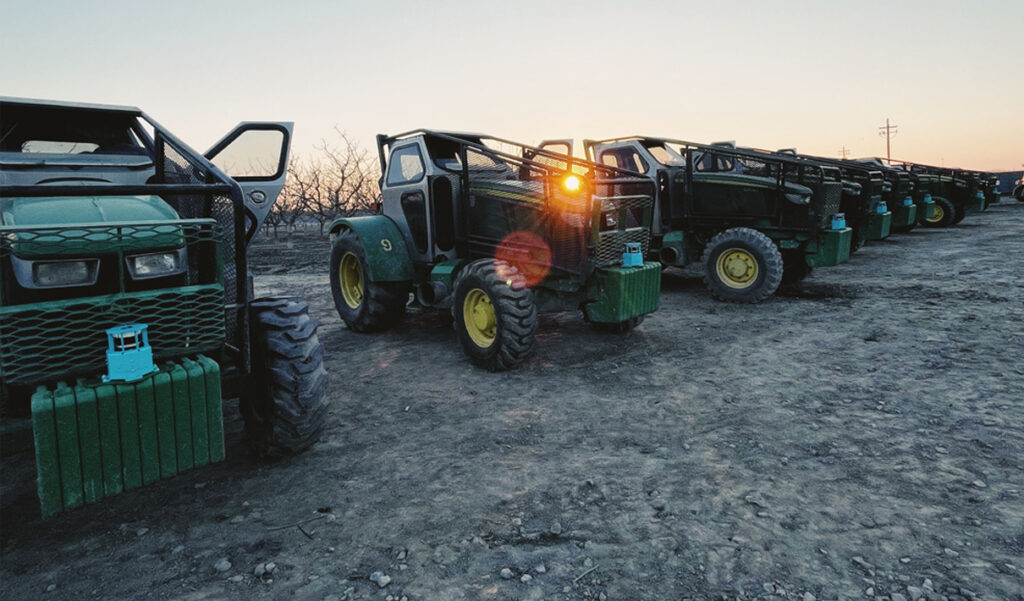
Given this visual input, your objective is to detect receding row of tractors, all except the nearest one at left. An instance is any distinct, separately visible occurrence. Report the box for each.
[330,130,999,371]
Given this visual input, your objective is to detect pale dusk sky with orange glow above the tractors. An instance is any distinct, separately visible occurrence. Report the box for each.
[0,0,1024,171]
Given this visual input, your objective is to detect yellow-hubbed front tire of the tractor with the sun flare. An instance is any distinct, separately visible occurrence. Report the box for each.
[452,259,538,372]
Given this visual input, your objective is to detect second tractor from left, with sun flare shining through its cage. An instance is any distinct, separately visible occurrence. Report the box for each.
[330,130,660,371]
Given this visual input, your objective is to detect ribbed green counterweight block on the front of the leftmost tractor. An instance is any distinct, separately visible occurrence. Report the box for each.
[32,355,224,516]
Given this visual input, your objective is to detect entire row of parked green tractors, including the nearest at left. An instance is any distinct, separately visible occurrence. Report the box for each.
[0,98,998,515]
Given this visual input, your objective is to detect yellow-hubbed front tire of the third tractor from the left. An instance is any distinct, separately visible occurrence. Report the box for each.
[701,227,782,303]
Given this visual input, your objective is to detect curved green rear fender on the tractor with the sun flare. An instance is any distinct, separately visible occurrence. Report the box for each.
[328,215,413,282]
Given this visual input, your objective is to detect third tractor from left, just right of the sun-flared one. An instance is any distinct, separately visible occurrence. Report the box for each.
[584,136,852,303]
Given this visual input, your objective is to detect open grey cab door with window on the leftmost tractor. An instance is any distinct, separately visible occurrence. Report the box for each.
[204,121,292,240]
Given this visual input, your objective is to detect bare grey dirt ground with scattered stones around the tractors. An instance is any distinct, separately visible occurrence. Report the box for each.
[0,203,1024,601]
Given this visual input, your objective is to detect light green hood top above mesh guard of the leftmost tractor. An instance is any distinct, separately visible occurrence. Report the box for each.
[0,197,178,226]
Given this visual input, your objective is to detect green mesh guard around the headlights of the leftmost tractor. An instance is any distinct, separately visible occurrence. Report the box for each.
[0,219,224,384]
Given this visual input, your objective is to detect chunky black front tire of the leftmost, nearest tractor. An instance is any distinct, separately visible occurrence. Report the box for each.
[240,298,328,457]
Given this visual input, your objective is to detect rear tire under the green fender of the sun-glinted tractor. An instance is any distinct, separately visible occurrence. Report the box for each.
[331,229,410,332]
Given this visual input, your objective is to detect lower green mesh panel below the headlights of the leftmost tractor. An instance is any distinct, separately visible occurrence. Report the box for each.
[0,284,224,384]
